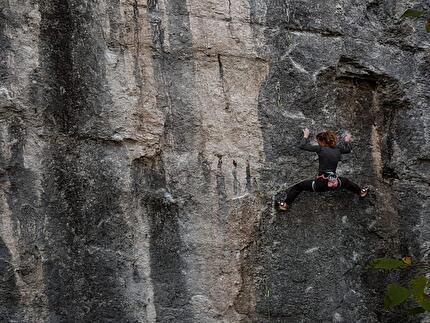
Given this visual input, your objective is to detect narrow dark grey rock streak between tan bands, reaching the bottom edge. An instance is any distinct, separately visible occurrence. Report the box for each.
[133,155,192,322]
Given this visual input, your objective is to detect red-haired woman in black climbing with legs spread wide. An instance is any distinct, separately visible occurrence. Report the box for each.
[279,128,369,211]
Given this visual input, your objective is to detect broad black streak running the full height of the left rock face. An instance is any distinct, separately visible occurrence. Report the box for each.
[38,0,136,322]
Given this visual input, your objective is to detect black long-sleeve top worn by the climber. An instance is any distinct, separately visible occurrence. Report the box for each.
[300,138,351,173]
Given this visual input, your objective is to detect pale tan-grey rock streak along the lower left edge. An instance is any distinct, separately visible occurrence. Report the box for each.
[0,117,43,317]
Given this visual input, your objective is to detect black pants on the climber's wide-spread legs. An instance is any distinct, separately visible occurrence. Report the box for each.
[285,177,361,205]
